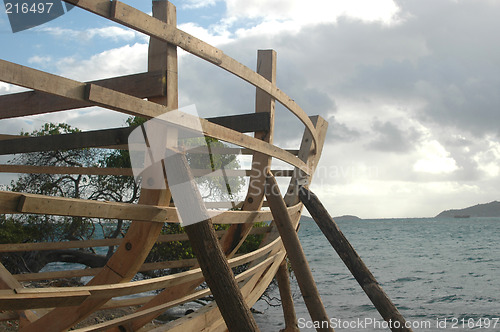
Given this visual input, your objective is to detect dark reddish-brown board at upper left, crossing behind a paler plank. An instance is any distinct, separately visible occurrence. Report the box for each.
[0,71,166,119]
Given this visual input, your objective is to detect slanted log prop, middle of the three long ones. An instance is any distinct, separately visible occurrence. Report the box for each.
[266,173,333,332]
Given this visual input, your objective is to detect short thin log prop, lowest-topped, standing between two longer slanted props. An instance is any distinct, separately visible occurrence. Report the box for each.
[276,259,300,332]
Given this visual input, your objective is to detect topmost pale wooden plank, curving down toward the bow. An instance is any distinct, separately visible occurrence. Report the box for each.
[60,0,317,150]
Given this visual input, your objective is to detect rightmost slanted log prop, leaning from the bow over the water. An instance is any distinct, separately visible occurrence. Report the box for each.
[299,187,412,332]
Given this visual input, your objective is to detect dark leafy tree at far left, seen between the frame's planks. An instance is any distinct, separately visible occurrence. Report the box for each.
[0,123,139,273]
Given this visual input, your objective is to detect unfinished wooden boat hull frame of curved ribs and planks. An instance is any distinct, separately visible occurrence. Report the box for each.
[0,0,328,331]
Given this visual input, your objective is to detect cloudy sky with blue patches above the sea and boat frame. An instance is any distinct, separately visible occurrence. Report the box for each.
[0,0,500,218]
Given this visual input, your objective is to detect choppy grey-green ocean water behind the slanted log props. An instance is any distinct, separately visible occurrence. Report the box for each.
[254,218,500,331]
